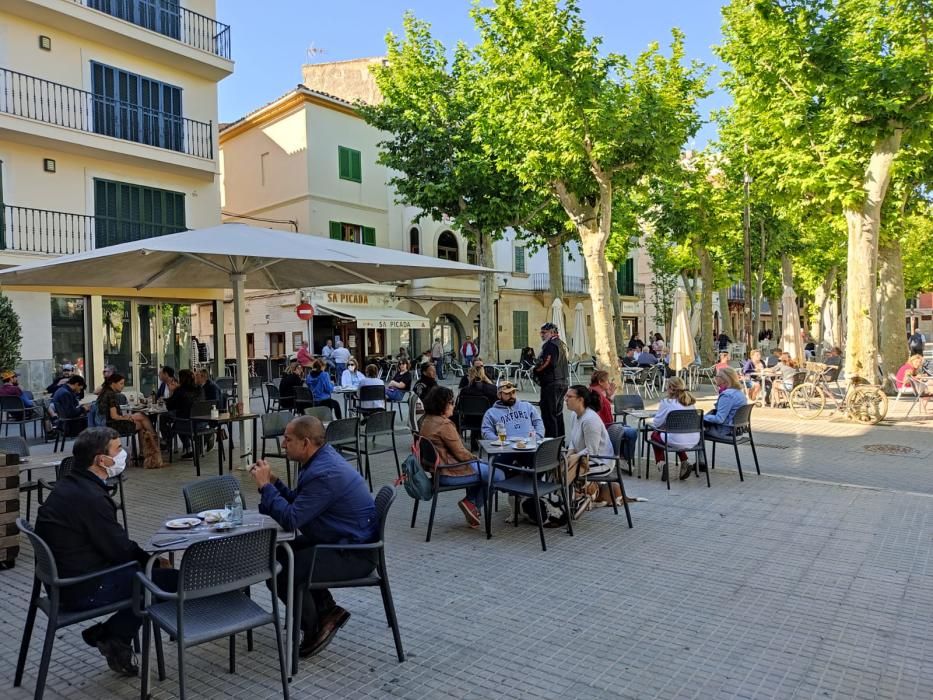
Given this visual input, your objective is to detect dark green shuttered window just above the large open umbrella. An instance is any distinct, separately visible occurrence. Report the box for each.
[94,178,186,248]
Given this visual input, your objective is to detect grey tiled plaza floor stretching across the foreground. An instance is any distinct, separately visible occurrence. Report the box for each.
[0,388,933,700]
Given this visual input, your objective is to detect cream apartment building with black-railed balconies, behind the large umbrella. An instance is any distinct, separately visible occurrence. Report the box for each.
[0,0,233,391]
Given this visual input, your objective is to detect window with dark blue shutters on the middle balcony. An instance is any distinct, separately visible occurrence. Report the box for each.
[91,61,185,151]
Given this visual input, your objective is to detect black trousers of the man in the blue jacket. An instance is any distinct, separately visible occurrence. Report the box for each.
[276,539,378,635]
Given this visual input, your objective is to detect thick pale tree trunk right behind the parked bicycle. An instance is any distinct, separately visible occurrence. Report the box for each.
[845,127,903,382]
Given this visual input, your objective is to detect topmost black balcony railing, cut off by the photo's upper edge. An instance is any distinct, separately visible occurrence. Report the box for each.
[74,0,231,59]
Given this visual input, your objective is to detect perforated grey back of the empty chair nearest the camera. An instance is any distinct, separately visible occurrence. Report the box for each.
[178,527,276,604]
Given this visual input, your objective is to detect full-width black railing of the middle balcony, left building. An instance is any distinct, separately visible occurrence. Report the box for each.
[0,68,214,160]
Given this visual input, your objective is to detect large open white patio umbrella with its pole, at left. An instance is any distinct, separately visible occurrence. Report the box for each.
[0,223,487,462]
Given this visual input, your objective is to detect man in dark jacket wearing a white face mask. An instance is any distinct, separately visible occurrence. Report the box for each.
[36,428,178,676]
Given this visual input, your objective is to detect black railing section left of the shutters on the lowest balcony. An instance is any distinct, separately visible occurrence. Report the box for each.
[0,205,94,255]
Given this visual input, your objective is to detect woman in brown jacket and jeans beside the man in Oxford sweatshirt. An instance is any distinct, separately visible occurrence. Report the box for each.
[420,386,505,528]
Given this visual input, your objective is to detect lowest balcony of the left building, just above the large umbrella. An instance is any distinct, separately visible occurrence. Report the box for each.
[0,205,184,255]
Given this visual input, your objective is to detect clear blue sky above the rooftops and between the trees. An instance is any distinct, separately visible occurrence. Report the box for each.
[217,0,728,146]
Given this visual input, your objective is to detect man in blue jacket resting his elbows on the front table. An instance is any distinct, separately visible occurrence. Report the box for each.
[250,416,379,658]
